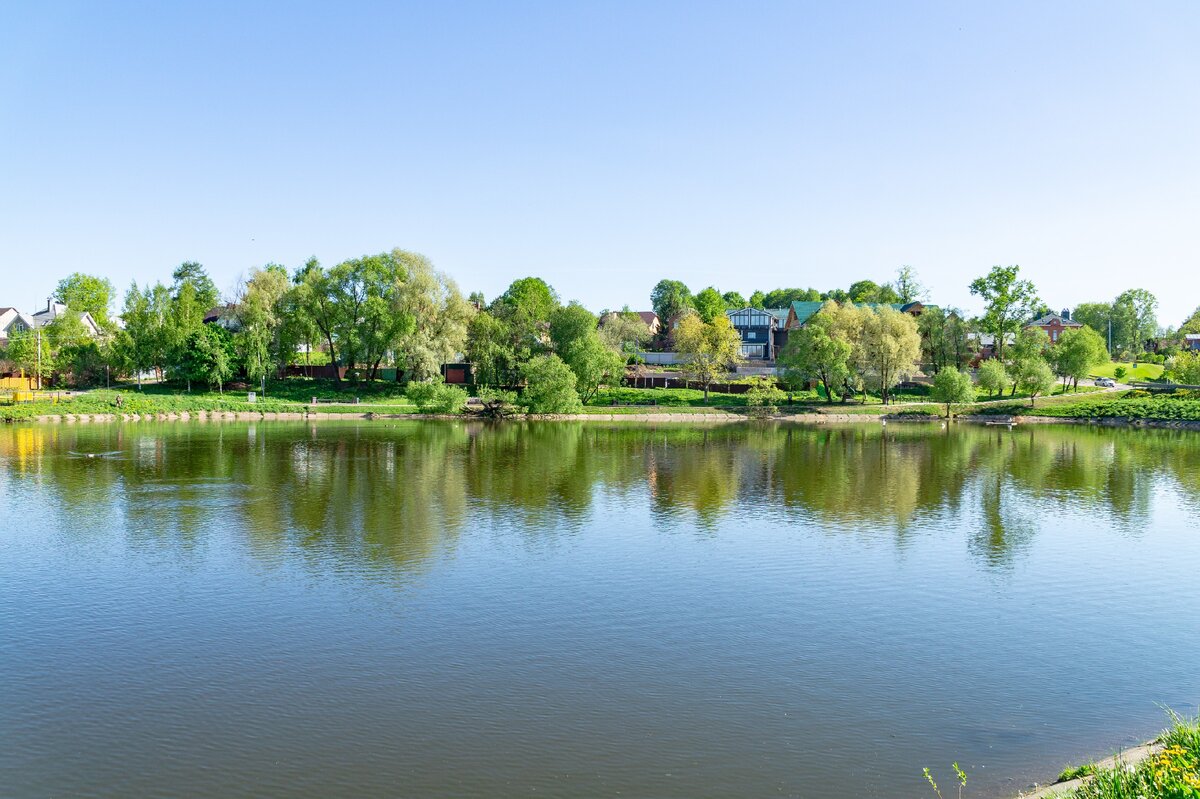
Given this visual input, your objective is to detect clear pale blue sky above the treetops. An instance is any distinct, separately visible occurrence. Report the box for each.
[0,1,1200,325]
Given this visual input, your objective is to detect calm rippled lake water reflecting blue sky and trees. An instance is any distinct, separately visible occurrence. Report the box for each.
[0,422,1200,799]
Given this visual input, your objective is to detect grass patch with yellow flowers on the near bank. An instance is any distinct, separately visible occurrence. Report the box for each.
[1064,715,1200,799]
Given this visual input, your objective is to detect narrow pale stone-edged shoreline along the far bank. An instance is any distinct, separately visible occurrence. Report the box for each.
[14,410,1200,431]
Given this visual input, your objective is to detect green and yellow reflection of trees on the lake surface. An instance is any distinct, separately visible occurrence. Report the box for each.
[0,422,1200,570]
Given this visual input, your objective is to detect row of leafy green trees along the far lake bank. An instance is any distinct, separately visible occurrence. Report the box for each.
[5,248,1200,405]
